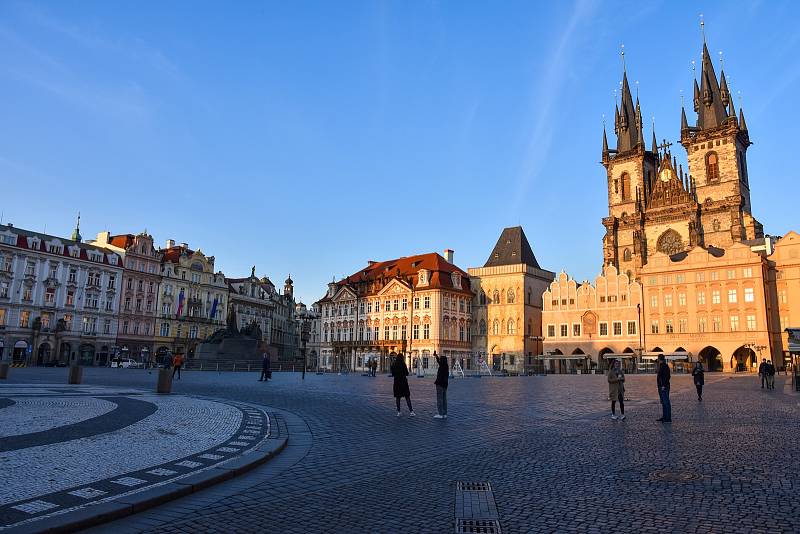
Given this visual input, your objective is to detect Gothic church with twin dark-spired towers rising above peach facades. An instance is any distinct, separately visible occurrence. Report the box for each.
[602,37,764,278]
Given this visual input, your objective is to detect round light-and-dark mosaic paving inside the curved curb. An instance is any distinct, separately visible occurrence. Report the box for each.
[0,384,269,530]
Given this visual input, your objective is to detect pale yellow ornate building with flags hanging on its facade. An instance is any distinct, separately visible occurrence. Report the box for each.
[154,240,228,360]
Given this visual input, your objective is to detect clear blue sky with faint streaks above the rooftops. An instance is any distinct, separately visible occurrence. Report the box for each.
[0,0,800,303]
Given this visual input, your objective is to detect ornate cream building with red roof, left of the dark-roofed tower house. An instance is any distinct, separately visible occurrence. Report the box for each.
[317,250,473,374]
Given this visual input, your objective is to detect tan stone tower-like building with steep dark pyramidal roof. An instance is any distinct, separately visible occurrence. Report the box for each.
[465,226,554,373]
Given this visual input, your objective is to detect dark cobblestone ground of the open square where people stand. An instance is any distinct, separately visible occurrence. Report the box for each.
[3,369,800,534]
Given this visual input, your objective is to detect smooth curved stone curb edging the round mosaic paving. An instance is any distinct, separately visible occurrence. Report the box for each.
[3,437,288,534]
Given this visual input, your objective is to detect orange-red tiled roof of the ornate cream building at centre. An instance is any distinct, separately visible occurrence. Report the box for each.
[320,252,473,302]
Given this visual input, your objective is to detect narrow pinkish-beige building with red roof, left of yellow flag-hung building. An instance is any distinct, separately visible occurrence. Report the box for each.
[91,232,161,363]
